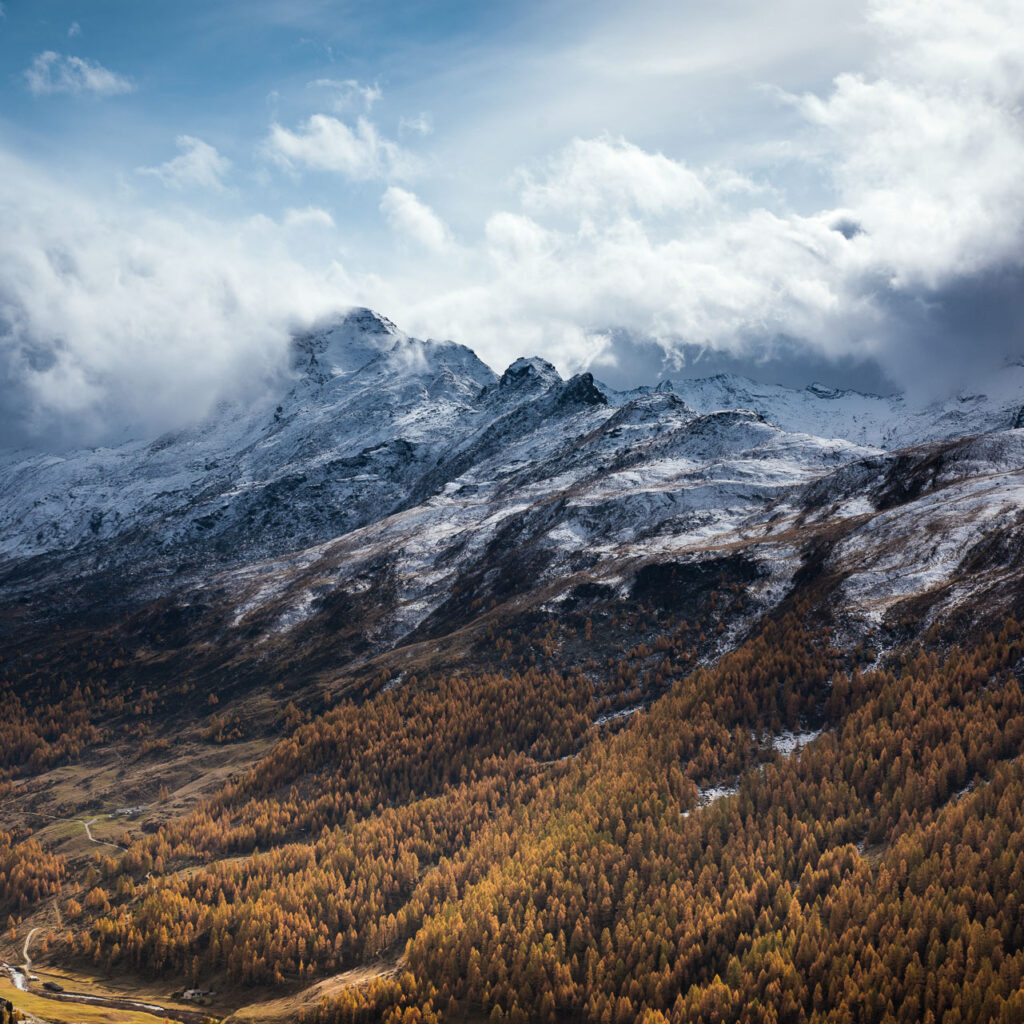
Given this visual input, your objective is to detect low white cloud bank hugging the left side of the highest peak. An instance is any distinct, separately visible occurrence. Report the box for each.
[0,152,353,447]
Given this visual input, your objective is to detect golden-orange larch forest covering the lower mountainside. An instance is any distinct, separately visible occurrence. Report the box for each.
[8,606,1024,1024]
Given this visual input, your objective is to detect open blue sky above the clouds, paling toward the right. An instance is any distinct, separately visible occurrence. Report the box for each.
[0,0,863,237]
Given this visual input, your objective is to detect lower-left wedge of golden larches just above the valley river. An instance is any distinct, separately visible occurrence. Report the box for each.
[79,758,534,984]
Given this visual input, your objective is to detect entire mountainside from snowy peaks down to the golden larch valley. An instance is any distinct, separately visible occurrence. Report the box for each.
[0,309,1024,1024]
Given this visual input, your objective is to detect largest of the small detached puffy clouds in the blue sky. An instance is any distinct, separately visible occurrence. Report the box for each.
[265,114,414,181]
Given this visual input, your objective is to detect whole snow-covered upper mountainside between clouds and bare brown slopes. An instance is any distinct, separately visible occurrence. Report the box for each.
[0,309,1024,639]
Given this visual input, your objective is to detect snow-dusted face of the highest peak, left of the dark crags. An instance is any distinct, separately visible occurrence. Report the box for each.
[0,310,495,573]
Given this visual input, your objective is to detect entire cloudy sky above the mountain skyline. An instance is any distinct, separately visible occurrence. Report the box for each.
[0,0,1024,438]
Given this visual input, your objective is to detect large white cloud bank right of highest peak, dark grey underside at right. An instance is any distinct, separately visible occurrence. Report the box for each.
[382,0,1024,388]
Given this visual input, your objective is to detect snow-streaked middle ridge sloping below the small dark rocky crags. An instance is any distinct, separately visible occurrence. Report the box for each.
[209,399,877,642]
